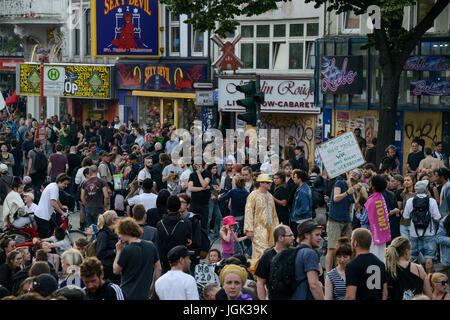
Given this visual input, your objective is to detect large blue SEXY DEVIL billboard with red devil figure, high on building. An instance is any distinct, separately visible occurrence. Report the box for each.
[91,0,159,57]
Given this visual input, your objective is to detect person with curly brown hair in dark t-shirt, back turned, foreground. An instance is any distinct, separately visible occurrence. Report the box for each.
[113,218,161,300]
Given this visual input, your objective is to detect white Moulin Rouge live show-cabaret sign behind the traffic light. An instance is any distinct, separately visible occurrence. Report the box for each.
[218,77,320,114]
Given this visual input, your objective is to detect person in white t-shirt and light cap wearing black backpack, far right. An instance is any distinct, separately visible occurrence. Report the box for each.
[403,180,441,273]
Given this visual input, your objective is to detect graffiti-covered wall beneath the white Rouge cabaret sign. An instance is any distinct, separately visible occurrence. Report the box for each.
[261,114,315,163]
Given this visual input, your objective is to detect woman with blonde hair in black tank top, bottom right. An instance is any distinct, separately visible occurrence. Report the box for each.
[385,236,431,300]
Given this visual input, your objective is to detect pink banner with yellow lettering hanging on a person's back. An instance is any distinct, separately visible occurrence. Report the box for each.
[364,192,391,245]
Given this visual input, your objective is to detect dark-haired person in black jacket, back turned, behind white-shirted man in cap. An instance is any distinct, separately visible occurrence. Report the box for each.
[156,196,192,274]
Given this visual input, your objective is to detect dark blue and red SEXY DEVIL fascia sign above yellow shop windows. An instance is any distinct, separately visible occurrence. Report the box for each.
[115,63,207,92]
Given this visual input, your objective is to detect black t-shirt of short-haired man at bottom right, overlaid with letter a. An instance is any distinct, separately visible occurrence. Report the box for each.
[345,253,387,300]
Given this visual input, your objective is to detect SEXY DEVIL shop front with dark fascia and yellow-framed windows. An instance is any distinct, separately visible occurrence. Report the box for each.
[115,59,208,130]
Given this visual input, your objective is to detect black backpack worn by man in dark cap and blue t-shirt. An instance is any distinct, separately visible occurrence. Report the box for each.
[269,244,309,300]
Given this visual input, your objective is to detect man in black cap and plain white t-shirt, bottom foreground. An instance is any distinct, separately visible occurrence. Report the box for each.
[155,245,199,300]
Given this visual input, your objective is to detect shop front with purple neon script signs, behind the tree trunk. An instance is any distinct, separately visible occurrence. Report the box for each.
[315,37,450,173]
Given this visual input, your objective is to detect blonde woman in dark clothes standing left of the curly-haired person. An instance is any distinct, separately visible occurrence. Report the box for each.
[95,210,120,284]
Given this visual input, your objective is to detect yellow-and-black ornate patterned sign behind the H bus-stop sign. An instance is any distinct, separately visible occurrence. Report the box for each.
[16,63,112,99]
